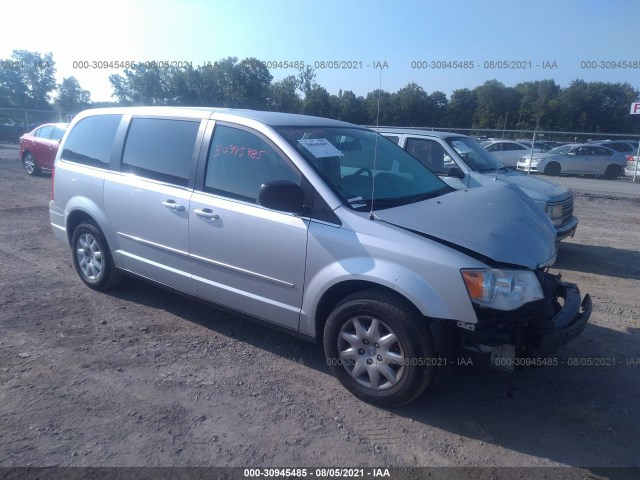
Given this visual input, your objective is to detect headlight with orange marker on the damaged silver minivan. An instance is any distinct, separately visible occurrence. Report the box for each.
[462,269,544,310]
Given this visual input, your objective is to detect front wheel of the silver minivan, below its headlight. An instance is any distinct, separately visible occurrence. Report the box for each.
[323,290,437,407]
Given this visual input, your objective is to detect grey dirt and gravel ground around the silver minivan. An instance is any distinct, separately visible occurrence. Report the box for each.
[0,144,640,474]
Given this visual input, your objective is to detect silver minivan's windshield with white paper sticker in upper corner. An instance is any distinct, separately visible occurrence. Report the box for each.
[276,127,452,210]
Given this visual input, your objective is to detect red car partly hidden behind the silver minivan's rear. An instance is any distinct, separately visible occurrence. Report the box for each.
[20,123,69,175]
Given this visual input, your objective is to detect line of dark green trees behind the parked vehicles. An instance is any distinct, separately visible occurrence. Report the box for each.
[0,50,640,133]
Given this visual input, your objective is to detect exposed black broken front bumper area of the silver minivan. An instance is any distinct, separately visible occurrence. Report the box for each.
[457,272,592,371]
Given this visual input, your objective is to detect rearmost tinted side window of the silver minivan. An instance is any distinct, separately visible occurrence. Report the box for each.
[62,115,122,168]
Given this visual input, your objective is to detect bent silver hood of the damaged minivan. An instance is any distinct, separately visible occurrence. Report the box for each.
[376,185,556,269]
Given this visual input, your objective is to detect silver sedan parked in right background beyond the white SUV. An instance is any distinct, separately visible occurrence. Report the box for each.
[517,144,627,179]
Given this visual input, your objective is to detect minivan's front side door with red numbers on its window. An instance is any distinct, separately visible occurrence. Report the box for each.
[189,123,309,330]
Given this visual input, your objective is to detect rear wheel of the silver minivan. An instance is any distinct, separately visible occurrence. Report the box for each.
[71,221,122,290]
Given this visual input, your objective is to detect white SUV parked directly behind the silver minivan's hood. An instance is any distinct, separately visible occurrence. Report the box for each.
[374,127,578,240]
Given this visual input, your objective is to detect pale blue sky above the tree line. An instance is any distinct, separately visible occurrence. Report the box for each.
[0,0,640,101]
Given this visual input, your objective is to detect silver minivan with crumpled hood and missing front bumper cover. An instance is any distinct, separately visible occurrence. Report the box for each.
[50,107,591,405]
